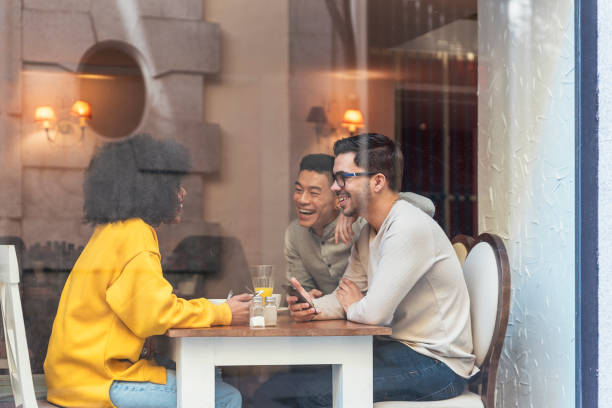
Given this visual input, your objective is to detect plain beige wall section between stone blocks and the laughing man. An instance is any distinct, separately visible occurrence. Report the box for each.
[203,0,289,273]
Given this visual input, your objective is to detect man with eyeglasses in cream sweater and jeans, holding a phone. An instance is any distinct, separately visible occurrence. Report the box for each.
[290,133,477,408]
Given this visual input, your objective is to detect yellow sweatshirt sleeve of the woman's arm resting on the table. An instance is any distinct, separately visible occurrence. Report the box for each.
[106,251,232,338]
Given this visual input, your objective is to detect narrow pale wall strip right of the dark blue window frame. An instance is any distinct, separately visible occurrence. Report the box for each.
[597,0,612,407]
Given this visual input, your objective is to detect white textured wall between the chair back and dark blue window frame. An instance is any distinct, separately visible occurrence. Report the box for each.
[478,0,575,408]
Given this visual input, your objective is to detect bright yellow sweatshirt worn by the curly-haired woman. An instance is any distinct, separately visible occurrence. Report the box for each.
[44,218,232,408]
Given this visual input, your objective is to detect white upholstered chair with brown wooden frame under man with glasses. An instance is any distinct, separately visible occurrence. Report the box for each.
[374,234,510,408]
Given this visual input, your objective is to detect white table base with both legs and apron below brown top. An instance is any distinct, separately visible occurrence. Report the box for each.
[173,336,373,408]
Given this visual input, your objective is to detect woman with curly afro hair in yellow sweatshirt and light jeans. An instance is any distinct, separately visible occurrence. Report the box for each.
[44,135,250,408]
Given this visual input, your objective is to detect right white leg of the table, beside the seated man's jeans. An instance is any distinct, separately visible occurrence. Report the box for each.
[332,336,374,408]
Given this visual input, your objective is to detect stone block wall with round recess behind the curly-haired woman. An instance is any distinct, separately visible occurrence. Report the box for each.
[3,1,220,255]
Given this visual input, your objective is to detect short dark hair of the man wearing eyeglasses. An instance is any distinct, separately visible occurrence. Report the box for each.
[334,133,404,191]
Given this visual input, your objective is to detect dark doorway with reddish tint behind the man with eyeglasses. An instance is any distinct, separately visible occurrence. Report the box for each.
[396,58,478,236]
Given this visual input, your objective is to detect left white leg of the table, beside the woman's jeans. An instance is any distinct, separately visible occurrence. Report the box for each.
[173,337,215,408]
